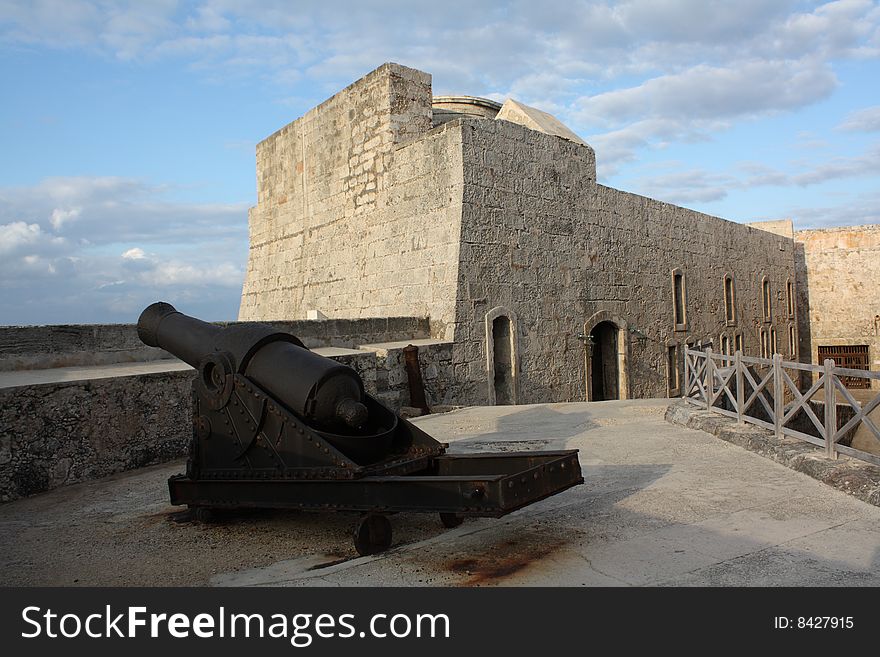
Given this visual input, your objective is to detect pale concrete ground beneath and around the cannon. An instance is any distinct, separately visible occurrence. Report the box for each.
[0,400,880,586]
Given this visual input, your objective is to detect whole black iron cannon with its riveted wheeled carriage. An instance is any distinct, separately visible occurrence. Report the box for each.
[138,302,583,555]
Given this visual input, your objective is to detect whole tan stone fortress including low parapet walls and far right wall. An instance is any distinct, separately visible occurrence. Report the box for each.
[0,64,880,500]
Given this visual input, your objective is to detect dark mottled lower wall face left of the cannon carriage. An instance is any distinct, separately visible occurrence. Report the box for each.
[0,370,194,502]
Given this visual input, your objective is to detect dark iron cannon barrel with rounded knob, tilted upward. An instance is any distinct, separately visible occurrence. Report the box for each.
[137,302,369,431]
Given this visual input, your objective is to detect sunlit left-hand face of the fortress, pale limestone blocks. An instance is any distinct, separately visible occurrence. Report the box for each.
[239,64,462,332]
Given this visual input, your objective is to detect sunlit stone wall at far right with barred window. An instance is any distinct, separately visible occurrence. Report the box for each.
[795,225,880,388]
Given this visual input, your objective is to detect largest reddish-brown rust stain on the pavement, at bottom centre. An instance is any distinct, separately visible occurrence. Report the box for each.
[445,536,565,586]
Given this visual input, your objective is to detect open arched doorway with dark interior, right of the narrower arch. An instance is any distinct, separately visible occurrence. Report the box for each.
[583,311,629,401]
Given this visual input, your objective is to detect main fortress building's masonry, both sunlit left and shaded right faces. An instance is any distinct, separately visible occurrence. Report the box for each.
[240,64,795,403]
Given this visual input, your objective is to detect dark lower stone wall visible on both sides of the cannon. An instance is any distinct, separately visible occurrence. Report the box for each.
[0,340,455,502]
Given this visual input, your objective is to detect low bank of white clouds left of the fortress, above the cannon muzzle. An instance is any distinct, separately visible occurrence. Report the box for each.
[0,177,248,324]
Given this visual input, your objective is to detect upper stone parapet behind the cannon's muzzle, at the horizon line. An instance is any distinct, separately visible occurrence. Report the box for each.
[0,317,431,371]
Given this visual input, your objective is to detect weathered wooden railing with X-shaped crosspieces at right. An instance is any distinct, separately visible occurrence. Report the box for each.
[682,347,880,465]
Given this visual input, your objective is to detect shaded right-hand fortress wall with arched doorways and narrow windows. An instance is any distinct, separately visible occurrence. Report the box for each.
[447,119,794,403]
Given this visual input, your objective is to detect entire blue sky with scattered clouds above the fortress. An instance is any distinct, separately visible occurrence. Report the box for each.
[0,0,880,324]
